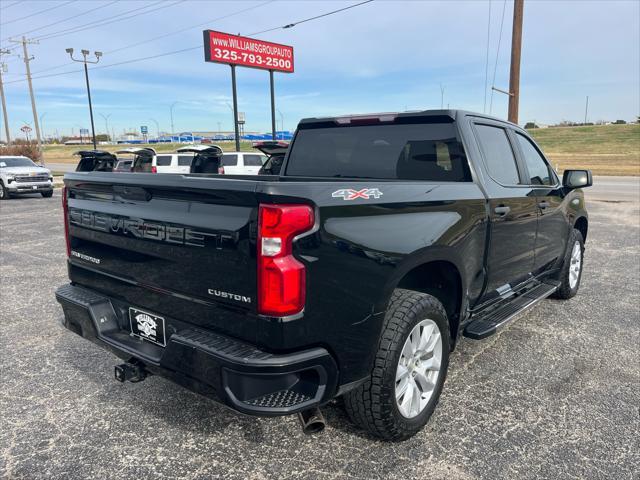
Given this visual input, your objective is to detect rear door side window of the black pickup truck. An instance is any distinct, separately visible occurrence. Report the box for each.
[476,125,520,185]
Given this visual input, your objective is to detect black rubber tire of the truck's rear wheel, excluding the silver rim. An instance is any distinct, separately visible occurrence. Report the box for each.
[344,289,450,441]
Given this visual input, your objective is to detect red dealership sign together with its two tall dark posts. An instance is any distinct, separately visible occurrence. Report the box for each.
[202,30,293,150]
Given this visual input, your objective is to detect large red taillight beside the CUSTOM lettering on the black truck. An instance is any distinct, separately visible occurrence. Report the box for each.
[258,205,315,317]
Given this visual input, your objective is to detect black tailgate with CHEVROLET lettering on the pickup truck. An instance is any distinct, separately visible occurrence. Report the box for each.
[65,173,258,336]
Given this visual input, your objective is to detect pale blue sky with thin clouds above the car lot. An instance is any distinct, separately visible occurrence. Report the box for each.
[0,0,640,137]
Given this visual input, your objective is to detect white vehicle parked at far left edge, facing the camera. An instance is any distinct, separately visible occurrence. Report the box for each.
[0,156,53,200]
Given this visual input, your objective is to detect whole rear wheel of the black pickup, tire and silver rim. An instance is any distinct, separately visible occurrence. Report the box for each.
[345,289,450,440]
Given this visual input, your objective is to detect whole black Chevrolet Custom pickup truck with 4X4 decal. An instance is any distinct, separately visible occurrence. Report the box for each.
[56,110,592,440]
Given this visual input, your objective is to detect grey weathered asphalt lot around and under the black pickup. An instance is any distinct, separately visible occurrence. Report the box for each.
[0,178,640,479]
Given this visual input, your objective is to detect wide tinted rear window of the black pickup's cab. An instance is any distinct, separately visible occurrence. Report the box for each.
[286,123,471,182]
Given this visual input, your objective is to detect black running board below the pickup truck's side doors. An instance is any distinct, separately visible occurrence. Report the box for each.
[463,282,559,340]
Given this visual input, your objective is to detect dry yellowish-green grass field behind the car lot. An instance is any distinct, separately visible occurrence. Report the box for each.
[44,124,640,175]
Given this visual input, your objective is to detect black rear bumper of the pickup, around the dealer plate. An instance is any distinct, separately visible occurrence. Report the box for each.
[56,285,338,415]
